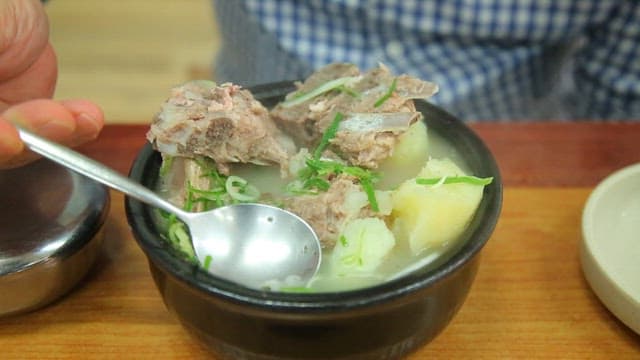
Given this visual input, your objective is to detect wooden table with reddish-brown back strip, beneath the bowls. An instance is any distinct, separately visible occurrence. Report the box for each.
[0,122,640,359]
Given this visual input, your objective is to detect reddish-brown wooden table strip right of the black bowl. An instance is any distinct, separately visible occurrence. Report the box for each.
[471,122,640,186]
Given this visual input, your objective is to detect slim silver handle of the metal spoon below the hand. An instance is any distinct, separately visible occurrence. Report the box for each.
[18,127,184,216]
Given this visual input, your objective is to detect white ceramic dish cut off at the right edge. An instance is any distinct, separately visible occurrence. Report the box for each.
[580,163,640,334]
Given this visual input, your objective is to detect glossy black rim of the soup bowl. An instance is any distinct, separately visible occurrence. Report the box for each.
[125,81,502,313]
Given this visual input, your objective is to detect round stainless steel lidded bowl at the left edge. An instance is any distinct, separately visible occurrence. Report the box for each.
[0,159,109,316]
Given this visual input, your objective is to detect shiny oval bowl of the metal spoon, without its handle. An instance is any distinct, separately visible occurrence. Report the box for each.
[182,204,320,288]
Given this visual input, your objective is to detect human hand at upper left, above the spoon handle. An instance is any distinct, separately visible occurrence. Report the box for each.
[0,0,104,169]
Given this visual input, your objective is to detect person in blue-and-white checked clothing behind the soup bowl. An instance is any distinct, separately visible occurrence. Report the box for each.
[214,0,640,121]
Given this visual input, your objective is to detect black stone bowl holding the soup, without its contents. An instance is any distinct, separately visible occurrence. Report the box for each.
[125,82,502,359]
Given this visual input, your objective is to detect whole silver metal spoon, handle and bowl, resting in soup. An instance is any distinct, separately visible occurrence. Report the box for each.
[18,129,321,288]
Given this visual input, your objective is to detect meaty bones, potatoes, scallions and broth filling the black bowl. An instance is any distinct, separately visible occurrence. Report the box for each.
[148,64,491,292]
